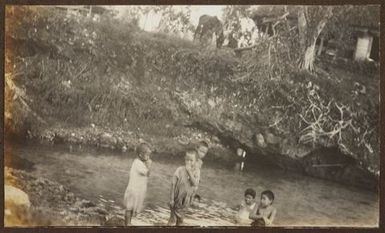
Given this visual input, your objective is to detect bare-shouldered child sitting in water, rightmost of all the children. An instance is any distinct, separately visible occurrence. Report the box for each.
[249,190,277,227]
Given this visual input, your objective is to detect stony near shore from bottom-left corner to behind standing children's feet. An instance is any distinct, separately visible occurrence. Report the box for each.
[5,167,236,226]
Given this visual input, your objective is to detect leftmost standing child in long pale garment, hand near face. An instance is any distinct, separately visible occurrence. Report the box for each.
[124,143,152,226]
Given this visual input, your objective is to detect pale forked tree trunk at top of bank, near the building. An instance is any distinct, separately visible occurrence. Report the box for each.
[298,6,333,72]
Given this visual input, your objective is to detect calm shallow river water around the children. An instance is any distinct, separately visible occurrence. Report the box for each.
[7,144,379,227]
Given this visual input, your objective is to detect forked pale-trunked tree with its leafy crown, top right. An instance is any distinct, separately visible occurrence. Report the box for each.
[249,5,380,71]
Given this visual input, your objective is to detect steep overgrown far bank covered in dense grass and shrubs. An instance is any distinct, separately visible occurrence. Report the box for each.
[6,6,379,177]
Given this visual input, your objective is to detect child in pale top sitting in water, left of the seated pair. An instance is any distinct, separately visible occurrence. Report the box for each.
[235,188,256,226]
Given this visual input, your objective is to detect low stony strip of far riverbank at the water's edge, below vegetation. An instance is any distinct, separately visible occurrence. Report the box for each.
[15,123,237,163]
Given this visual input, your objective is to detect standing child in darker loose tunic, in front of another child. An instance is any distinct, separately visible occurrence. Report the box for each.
[167,149,200,226]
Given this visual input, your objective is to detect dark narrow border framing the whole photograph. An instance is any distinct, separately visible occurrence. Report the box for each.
[0,0,385,232]
